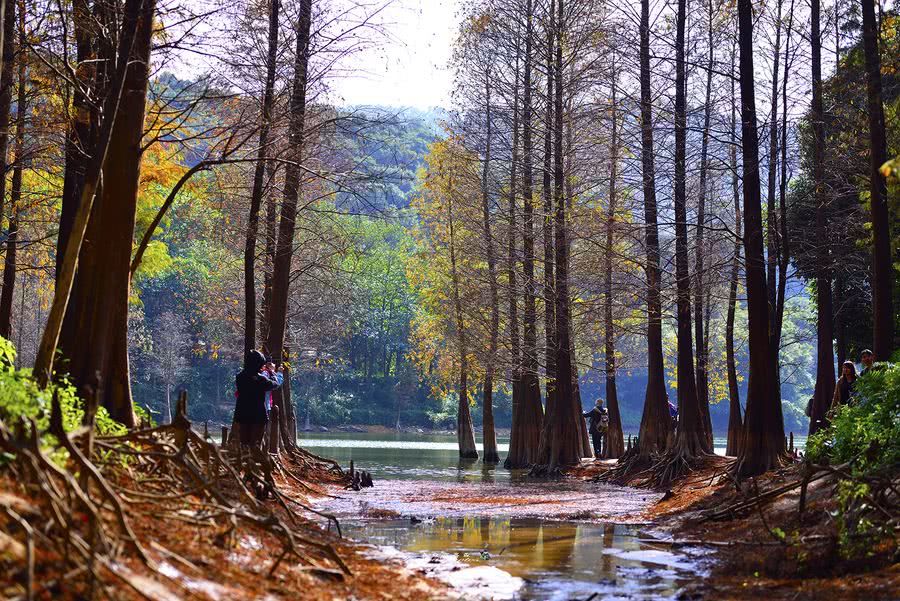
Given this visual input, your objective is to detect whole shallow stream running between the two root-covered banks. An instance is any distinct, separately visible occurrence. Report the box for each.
[308,433,718,601]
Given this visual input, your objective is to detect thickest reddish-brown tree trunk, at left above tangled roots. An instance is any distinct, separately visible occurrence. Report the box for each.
[51,0,155,427]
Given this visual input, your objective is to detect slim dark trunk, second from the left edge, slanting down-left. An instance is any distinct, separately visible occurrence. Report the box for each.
[0,7,28,339]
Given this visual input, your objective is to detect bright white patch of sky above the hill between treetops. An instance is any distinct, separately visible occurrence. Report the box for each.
[332,0,459,109]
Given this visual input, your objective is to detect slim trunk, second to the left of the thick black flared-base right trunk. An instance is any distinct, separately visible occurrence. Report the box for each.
[694,0,713,449]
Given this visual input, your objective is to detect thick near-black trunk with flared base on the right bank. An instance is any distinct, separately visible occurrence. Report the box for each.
[736,0,784,476]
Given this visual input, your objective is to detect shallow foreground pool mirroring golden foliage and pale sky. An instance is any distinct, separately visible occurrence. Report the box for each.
[342,517,696,599]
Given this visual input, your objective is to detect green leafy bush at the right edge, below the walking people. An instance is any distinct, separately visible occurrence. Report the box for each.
[807,363,900,475]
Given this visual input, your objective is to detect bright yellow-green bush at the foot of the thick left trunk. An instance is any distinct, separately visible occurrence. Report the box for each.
[0,338,126,464]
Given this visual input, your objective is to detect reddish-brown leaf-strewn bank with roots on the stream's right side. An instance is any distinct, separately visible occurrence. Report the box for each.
[575,457,900,601]
